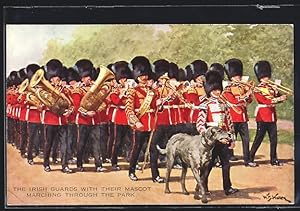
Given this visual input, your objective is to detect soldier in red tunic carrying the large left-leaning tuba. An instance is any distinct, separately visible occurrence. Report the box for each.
[42,59,73,174]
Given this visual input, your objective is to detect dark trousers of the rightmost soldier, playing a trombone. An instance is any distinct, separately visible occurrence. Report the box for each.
[250,122,277,163]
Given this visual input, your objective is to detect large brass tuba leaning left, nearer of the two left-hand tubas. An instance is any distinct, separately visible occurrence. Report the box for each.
[29,69,71,115]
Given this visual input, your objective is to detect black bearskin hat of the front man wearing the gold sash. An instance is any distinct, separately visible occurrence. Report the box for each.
[129,56,152,81]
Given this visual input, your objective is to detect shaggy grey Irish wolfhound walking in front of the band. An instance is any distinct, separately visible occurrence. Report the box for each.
[157,127,230,203]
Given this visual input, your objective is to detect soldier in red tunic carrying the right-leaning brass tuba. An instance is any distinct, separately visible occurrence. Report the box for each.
[73,59,106,172]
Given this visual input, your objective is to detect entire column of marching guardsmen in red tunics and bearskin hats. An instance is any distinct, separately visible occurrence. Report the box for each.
[6,56,287,183]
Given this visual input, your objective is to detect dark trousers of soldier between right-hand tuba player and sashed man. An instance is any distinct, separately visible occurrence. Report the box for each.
[111,124,132,165]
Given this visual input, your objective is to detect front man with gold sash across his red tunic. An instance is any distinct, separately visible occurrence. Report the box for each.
[125,56,163,182]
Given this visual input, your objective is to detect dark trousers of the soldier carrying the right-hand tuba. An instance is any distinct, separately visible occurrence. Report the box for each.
[77,125,102,168]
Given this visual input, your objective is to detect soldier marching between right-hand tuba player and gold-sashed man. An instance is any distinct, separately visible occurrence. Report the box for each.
[110,61,132,171]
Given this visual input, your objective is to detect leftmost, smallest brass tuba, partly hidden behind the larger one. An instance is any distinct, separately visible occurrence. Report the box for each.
[18,78,42,107]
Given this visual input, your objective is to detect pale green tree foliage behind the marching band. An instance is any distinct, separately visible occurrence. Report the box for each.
[41,24,294,120]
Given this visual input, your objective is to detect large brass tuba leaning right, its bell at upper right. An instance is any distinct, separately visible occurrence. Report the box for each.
[79,65,115,111]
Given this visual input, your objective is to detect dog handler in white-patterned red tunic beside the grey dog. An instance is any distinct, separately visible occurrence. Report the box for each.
[196,71,238,195]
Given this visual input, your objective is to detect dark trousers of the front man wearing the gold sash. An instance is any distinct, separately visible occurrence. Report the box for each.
[129,131,159,179]
